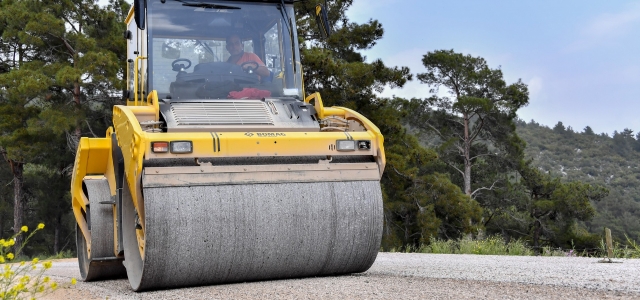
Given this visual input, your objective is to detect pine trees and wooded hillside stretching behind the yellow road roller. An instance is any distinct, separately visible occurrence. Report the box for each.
[0,0,640,255]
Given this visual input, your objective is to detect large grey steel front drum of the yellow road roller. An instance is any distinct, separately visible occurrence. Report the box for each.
[123,181,382,291]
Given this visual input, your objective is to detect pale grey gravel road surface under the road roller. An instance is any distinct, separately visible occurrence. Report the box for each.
[46,253,640,300]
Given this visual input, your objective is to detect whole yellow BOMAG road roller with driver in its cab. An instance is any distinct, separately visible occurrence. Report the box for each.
[71,0,385,291]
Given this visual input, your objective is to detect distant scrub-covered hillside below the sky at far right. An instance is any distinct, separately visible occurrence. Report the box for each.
[517,120,640,240]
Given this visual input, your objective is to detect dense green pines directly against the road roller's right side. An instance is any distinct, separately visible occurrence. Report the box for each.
[295,0,481,249]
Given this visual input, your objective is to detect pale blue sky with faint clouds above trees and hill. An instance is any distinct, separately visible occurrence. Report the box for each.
[347,0,640,135]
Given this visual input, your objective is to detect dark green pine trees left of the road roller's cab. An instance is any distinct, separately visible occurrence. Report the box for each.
[0,0,129,253]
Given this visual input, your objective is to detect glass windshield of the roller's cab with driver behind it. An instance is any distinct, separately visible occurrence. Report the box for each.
[147,0,302,101]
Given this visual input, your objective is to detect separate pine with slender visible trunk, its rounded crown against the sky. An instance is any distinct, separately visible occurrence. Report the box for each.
[407,50,528,201]
